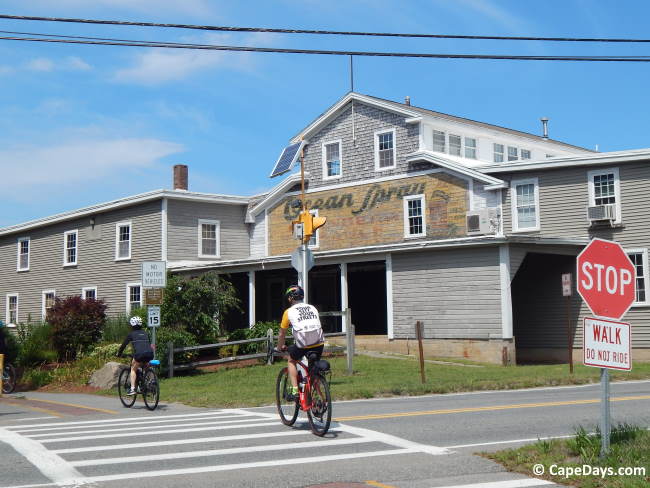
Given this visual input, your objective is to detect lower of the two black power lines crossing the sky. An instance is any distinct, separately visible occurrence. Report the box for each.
[0,34,650,63]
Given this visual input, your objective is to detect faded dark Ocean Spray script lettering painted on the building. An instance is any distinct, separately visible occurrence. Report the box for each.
[284,183,426,220]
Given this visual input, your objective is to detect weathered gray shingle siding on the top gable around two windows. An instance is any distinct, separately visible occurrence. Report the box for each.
[305,102,419,189]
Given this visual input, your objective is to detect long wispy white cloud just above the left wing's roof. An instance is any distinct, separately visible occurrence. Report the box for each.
[0,138,184,201]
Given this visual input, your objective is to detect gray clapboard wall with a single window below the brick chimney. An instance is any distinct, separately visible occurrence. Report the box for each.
[167,199,250,261]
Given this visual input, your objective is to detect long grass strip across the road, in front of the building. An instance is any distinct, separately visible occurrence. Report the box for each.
[147,355,650,407]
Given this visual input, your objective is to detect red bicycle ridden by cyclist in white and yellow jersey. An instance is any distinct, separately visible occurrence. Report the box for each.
[275,353,332,437]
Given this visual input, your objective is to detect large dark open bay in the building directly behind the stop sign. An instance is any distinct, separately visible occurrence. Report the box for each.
[511,253,580,363]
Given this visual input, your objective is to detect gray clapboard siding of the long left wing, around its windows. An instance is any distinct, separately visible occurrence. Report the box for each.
[0,200,161,322]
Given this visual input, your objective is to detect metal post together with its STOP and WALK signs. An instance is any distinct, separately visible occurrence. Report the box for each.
[576,239,636,457]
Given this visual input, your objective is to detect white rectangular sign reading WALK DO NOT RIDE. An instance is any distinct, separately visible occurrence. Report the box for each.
[583,317,632,371]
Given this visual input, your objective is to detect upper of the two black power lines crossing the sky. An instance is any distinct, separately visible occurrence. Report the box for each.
[0,15,650,43]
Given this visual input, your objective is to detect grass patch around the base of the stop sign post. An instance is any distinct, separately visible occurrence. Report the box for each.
[483,425,650,488]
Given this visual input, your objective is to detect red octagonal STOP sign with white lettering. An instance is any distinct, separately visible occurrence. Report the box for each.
[577,239,636,320]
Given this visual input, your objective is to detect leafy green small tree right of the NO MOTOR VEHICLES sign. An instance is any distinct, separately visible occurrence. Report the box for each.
[162,272,241,343]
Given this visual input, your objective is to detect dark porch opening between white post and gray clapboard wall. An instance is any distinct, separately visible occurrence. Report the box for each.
[348,261,388,335]
